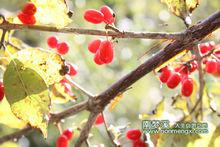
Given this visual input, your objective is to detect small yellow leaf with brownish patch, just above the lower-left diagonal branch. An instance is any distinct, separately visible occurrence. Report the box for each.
[50,83,76,103]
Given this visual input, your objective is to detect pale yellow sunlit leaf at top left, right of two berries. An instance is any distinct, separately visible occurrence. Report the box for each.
[31,0,71,27]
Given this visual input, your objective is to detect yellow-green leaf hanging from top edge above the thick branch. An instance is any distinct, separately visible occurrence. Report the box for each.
[161,0,199,25]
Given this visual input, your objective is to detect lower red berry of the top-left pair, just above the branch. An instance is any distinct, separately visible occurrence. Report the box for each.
[17,12,36,25]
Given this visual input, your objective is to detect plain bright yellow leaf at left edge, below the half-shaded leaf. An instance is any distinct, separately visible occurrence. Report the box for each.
[0,98,26,129]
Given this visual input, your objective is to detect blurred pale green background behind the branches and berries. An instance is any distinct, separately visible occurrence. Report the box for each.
[0,0,220,147]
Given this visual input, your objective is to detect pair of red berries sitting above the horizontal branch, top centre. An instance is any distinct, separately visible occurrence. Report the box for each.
[84,5,115,24]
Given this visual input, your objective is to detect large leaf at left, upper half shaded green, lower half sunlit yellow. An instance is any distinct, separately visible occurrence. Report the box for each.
[3,59,50,137]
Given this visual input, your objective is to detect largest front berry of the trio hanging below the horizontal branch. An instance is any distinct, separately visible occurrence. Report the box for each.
[99,40,114,64]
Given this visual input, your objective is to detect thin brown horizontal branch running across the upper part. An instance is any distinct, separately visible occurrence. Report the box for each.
[0,24,184,40]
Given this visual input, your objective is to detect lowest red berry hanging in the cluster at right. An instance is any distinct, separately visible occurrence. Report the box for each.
[181,78,193,97]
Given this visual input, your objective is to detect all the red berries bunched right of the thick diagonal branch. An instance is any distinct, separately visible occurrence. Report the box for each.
[159,41,220,97]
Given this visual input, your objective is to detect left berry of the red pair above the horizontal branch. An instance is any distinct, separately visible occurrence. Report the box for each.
[84,9,104,24]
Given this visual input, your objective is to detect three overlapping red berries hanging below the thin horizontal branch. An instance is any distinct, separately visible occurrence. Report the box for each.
[88,39,114,65]
